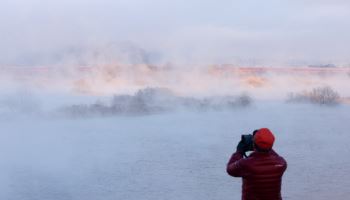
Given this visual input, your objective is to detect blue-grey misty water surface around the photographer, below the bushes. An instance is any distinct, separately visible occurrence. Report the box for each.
[0,102,350,200]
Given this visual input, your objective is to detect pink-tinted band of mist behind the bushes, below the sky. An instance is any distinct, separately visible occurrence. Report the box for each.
[1,63,350,99]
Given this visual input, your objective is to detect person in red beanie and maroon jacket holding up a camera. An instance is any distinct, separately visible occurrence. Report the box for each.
[226,128,287,200]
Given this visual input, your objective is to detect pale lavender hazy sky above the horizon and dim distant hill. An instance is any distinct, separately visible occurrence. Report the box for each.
[0,0,350,65]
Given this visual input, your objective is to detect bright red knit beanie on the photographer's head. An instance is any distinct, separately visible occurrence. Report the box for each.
[254,128,275,150]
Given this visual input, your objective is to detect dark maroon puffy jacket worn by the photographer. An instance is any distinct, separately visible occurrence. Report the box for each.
[226,150,287,200]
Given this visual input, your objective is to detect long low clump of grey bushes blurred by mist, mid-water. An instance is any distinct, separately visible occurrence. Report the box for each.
[61,88,252,117]
